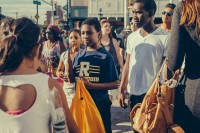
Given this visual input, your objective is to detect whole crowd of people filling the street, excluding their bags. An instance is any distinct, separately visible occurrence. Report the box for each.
[0,0,200,133]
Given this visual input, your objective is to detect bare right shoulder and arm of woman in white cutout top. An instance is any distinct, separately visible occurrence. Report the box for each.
[49,78,80,133]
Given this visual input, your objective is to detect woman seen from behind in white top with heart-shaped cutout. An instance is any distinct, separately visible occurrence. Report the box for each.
[0,18,78,133]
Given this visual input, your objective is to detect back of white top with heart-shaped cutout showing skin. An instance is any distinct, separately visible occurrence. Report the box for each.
[0,73,51,133]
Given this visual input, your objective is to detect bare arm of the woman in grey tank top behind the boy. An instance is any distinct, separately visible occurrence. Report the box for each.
[113,39,124,69]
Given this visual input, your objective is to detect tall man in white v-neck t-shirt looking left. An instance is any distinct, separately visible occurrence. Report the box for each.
[119,0,168,109]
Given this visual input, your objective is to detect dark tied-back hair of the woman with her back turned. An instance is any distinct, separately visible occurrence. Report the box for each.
[0,17,40,73]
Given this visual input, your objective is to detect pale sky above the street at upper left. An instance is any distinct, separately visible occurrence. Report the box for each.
[0,0,67,24]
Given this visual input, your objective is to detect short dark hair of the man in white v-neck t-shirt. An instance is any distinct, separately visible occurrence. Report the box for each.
[133,0,157,16]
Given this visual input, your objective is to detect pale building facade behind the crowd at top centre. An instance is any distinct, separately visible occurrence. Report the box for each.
[65,0,179,27]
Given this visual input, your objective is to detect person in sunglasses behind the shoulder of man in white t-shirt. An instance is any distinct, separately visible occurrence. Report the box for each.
[157,3,176,32]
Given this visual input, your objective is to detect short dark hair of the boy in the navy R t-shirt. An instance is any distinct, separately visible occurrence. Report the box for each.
[81,18,101,32]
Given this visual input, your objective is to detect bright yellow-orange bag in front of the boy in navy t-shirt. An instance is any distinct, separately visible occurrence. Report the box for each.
[70,80,105,133]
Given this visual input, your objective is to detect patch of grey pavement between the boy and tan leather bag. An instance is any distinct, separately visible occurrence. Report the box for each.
[111,100,133,133]
